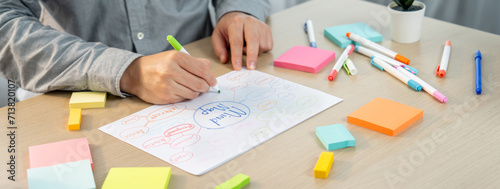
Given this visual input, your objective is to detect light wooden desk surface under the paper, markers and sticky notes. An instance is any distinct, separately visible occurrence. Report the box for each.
[0,0,500,188]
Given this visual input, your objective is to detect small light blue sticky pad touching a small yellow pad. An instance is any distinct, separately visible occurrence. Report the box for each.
[316,124,356,150]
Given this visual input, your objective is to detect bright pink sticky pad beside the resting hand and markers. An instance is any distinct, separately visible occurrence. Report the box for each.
[274,46,335,73]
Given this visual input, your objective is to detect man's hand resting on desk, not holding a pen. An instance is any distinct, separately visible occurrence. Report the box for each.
[212,12,273,70]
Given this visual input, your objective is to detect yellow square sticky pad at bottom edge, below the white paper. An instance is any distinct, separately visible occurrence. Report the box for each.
[102,167,171,189]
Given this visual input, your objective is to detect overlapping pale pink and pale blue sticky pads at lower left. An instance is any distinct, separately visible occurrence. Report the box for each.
[27,138,96,188]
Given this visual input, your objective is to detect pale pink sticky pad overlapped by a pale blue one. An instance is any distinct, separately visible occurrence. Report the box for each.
[29,138,94,169]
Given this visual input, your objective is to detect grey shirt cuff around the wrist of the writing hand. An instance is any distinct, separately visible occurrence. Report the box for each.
[87,48,143,97]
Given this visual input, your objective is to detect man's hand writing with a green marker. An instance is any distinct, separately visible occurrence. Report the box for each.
[120,51,217,104]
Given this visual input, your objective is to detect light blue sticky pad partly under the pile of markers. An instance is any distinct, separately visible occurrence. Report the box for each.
[324,22,382,48]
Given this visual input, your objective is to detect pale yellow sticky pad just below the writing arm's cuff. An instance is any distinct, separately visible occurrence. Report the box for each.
[69,92,106,109]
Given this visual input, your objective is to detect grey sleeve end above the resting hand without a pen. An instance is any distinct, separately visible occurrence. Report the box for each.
[215,0,271,22]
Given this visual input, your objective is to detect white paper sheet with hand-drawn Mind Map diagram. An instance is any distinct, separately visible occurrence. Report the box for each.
[99,70,342,175]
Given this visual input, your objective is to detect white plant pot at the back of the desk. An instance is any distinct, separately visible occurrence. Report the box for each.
[388,0,425,43]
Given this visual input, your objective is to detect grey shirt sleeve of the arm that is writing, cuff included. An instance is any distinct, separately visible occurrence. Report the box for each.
[0,0,141,96]
